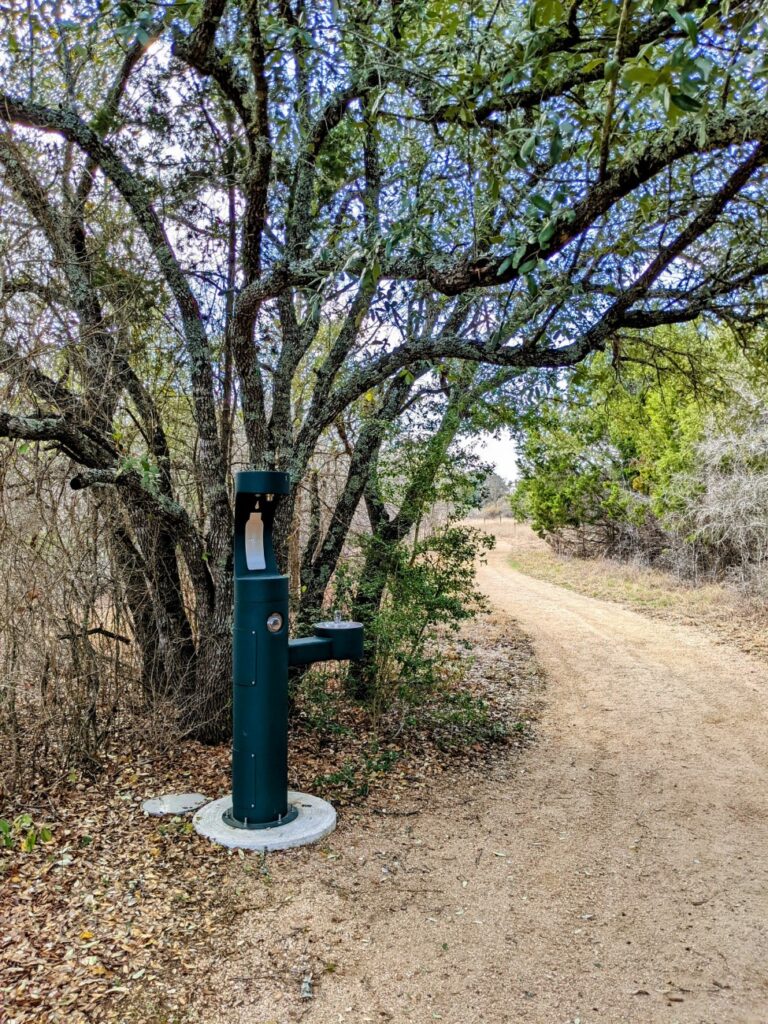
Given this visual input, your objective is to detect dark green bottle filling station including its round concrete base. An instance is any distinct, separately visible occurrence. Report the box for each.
[194,472,362,850]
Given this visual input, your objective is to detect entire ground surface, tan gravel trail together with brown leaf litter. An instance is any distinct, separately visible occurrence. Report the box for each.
[6,523,768,1024]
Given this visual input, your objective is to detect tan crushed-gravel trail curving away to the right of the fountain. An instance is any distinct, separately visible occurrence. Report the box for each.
[217,538,768,1024]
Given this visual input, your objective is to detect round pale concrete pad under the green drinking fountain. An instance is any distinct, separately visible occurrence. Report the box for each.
[193,790,336,853]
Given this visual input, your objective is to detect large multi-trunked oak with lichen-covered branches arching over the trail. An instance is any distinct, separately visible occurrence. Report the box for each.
[0,0,768,738]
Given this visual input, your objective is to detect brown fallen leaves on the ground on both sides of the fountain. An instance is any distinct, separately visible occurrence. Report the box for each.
[0,616,540,1024]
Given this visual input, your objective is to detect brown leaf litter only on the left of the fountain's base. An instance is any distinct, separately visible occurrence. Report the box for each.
[0,743,234,1024]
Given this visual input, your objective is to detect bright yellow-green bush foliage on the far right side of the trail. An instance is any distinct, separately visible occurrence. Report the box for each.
[511,328,762,557]
